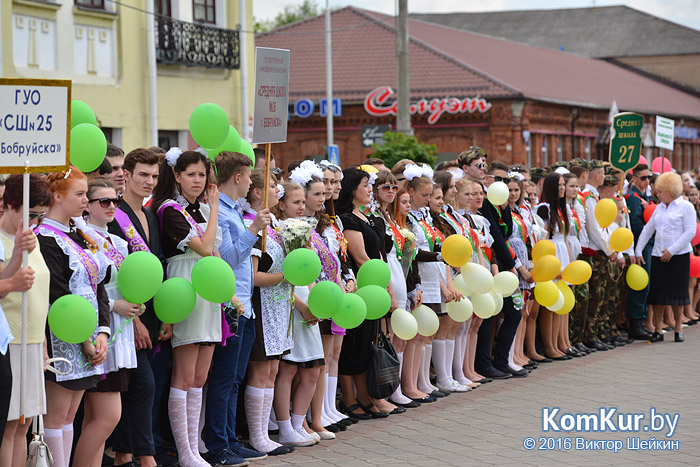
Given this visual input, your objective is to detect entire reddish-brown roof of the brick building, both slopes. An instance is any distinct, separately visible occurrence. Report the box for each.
[256,7,700,118]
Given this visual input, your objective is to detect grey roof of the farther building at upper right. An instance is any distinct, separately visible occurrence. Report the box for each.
[411,2,700,58]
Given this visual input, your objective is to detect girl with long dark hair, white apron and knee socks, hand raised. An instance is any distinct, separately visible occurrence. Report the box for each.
[151,148,221,467]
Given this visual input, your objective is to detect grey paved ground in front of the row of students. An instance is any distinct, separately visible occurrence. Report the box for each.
[258,325,700,467]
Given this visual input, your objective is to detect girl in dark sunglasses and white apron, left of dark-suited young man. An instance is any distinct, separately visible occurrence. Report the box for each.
[83,180,139,467]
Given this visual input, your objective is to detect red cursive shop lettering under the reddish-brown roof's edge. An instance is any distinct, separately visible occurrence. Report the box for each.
[365,86,491,125]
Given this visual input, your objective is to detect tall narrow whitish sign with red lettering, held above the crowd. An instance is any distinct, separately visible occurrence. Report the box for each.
[252,47,289,143]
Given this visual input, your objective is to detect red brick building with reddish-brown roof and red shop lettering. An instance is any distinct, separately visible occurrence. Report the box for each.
[256,7,700,172]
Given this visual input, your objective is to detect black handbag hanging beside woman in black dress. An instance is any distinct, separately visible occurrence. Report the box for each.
[367,321,401,399]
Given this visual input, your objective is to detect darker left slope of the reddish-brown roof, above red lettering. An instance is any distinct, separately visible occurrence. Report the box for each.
[255,7,517,100]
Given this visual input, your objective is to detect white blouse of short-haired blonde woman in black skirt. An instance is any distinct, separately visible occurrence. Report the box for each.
[635,196,696,256]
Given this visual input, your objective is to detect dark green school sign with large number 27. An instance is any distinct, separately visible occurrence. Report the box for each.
[610,112,644,172]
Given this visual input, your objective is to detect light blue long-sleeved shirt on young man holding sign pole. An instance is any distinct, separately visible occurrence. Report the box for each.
[218,193,258,318]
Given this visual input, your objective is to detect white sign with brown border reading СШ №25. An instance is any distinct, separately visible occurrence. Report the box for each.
[0,78,71,173]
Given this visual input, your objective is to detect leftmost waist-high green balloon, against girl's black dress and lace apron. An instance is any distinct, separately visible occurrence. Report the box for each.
[49,295,97,344]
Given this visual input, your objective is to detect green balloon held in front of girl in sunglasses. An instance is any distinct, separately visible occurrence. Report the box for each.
[117,251,163,303]
